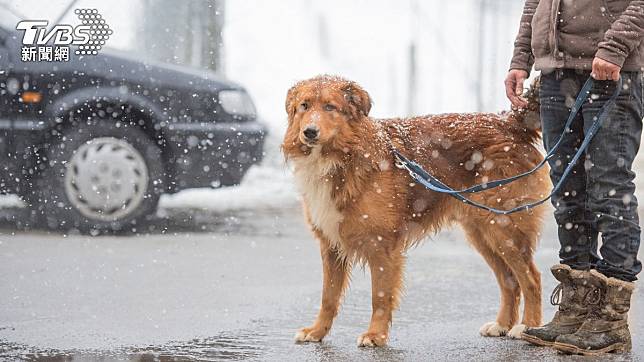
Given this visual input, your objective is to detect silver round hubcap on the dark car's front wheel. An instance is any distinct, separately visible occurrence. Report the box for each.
[65,137,149,221]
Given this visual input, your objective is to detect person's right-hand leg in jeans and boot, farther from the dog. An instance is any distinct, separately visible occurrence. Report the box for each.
[553,72,644,355]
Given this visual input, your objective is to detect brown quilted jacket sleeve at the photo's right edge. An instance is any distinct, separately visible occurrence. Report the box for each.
[595,0,644,67]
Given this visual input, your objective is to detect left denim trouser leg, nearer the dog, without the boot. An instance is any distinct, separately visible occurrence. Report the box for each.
[539,71,599,269]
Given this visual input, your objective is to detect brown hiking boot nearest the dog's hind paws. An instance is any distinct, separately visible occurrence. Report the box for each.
[521,264,591,346]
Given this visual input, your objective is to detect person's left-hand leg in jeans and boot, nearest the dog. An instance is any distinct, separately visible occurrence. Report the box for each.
[521,71,599,346]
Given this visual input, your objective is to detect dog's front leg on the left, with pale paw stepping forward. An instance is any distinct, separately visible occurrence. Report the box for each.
[295,240,350,342]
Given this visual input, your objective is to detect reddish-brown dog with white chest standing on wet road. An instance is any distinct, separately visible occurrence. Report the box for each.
[282,76,550,346]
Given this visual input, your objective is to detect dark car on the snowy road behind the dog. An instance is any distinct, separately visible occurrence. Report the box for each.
[0,21,266,231]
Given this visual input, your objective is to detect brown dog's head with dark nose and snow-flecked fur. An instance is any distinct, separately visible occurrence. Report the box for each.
[282,75,371,158]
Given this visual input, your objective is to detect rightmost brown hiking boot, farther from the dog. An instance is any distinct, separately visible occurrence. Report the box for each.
[554,270,635,356]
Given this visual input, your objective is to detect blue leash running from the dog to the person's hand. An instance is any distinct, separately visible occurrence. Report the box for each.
[393,77,622,215]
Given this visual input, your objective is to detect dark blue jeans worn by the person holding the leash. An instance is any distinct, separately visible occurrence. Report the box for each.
[539,69,644,281]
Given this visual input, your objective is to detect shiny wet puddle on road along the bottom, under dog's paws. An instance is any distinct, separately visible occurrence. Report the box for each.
[0,320,639,362]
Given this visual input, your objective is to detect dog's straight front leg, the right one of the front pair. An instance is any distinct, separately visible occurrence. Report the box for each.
[358,250,405,347]
